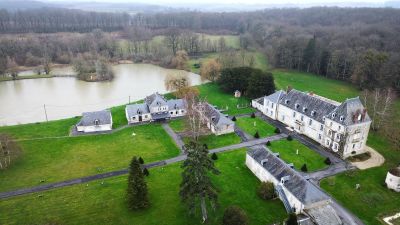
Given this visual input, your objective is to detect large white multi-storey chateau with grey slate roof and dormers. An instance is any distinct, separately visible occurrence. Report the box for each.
[252,89,371,158]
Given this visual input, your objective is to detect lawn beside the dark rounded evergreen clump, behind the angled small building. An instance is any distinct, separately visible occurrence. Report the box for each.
[198,83,255,115]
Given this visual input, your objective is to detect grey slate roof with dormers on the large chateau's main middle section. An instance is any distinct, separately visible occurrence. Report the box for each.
[279,89,337,123]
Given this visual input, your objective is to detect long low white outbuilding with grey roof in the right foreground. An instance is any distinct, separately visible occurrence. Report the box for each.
[246,147,342,225]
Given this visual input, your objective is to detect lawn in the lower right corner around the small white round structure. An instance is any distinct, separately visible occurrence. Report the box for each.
[321,132,400,225]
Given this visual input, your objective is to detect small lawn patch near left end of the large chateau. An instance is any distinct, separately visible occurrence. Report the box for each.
[235,117,275,137]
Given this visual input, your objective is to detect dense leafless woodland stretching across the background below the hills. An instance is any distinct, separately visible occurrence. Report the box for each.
[0,8,400,91]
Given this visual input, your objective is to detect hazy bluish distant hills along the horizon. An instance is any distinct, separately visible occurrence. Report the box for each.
[0,0,400,14]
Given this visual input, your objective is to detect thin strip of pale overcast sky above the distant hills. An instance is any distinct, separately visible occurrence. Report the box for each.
[45,0,384,4]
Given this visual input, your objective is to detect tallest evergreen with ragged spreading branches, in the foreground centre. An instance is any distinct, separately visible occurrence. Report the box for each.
[179,142,219,220]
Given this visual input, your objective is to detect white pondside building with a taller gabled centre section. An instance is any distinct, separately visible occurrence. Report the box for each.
[125,93,186,124]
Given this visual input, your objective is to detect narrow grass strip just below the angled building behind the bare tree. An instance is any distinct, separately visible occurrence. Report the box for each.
[184,133,241,149]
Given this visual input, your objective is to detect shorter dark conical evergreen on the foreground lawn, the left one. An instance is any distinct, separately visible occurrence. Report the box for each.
[127,156,150,210]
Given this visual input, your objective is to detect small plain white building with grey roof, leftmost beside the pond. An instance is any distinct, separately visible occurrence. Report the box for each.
[76,110,112,133]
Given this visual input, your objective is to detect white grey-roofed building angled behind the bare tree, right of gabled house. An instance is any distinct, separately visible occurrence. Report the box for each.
[199,103,235,135]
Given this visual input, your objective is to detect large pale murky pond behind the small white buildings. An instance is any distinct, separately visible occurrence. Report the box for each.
[0,64,202,126]
